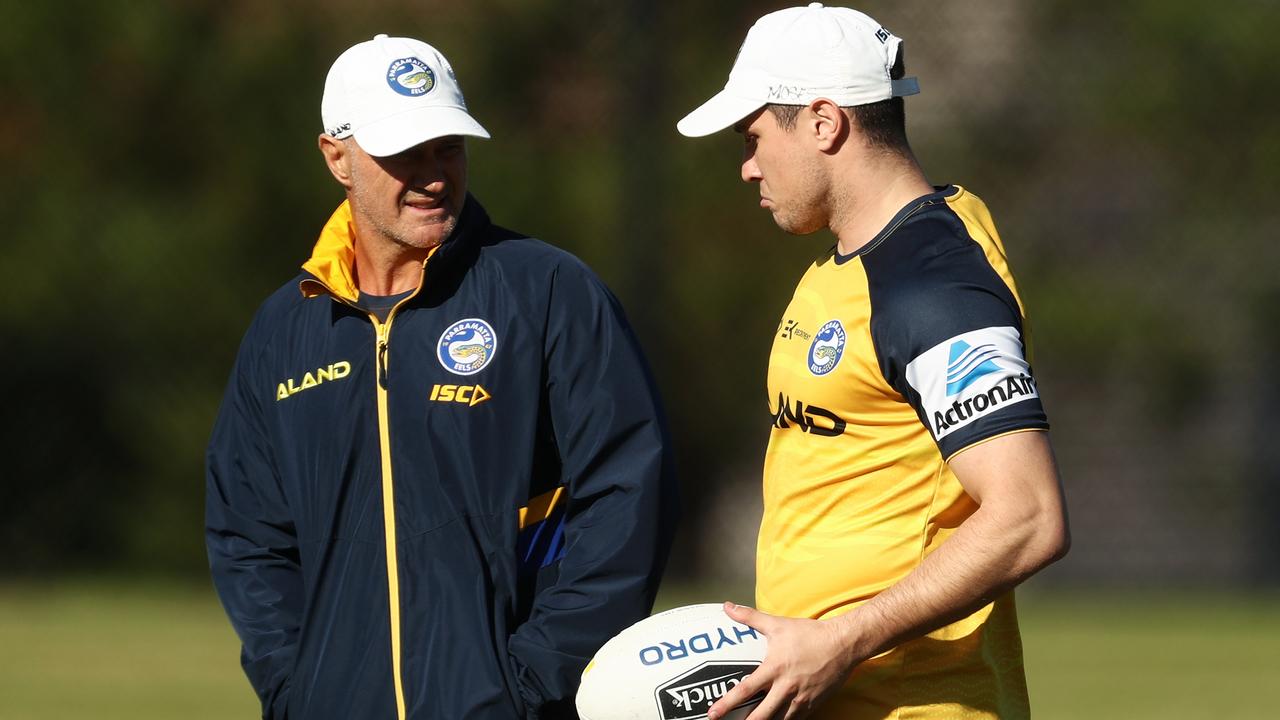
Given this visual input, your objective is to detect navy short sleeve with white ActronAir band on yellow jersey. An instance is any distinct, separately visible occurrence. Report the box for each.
[863,210,1048,457]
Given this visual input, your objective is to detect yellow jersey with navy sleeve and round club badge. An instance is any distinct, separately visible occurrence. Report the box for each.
[756,186,1048,720]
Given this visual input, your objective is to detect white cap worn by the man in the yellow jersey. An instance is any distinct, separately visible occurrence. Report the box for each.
[676,3,920,137]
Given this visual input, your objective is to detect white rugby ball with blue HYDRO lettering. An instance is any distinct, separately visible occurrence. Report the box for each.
[577,603,767,720]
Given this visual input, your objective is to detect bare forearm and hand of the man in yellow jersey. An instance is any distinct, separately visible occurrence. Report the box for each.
[708,432,1070,720]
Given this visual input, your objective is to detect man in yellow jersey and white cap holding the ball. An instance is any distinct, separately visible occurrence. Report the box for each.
[677,3,1069,720]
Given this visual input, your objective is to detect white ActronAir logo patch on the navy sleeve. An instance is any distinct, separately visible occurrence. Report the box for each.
[906,327,1039,439]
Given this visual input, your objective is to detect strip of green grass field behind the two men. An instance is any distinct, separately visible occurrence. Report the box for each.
[0,580,1280,720]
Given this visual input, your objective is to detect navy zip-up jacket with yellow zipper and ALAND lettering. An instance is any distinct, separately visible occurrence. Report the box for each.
[206,197,676,720]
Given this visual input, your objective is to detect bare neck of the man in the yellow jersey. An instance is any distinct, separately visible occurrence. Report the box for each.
[829,156,933,255]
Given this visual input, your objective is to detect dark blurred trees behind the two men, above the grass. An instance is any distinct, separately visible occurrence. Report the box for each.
[0,0,1280,597]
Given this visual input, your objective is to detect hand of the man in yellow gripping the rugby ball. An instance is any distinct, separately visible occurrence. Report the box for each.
[707,602,855,720]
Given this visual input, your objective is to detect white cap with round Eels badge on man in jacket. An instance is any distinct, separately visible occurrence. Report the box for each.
[320,35,489,158]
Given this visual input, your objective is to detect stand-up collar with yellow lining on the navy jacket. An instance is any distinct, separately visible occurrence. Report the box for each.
[298,193,489,302]
